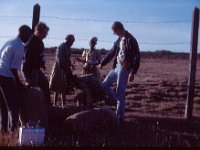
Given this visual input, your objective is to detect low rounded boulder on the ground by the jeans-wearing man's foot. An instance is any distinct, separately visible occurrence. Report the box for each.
[65,107,119,135]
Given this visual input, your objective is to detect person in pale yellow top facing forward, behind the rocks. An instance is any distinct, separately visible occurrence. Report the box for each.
[82,37,101,81]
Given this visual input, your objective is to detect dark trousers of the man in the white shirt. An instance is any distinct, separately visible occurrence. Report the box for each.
[0,75,20,132]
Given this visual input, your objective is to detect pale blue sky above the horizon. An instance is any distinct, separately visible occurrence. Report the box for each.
[0,0,200,53]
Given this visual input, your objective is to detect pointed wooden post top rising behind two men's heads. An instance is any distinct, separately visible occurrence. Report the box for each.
[32,4,40,31]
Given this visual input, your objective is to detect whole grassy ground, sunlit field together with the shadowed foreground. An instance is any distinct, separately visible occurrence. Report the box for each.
[40,52,200,147]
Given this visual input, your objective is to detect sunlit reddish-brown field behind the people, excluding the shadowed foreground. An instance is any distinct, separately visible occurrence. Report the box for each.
[45,52,200,118]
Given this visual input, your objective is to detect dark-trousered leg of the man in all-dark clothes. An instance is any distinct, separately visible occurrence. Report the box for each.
[38,70,51,104]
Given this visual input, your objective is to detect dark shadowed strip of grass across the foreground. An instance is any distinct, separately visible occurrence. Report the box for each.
[46,112,200,148]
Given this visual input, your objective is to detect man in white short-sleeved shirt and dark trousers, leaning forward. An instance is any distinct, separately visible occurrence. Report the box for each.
[0,25,32,133]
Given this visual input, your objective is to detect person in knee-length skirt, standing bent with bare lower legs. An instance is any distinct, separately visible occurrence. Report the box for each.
[49,34,75,106]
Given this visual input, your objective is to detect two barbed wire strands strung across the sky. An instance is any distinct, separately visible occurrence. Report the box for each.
[0,15,195,51]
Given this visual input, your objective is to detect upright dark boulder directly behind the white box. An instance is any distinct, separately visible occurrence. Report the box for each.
[20,87,48,127]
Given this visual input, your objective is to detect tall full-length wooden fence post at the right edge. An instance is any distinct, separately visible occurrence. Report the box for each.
[185,7,199,119]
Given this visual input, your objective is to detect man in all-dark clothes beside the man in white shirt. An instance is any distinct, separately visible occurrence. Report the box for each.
[22,22,51,104]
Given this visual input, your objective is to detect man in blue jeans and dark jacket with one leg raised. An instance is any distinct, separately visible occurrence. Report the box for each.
[99,21,140,123]
